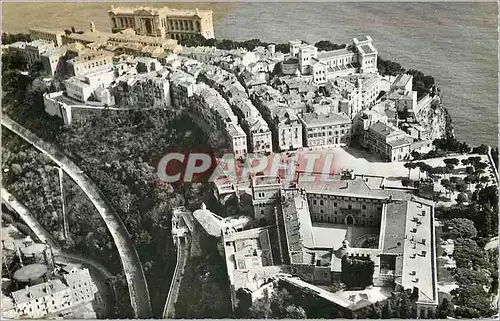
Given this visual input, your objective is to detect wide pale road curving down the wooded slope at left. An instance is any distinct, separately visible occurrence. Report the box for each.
[2,115,152,318]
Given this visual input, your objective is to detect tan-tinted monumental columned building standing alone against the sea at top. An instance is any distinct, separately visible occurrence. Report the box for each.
[108,6,214,40]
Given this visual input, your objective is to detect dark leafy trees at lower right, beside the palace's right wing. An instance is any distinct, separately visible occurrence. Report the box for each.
[437,179,498,318]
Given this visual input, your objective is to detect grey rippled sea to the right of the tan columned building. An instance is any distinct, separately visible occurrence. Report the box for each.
[215,2,498,146]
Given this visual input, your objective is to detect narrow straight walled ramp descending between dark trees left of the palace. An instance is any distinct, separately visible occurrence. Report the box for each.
[163,236,190,319]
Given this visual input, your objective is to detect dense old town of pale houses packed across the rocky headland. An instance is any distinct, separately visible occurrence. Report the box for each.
[8,13,435,161]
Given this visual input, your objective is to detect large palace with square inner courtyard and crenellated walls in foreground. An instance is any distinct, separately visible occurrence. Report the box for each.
[222,171,438,318]
